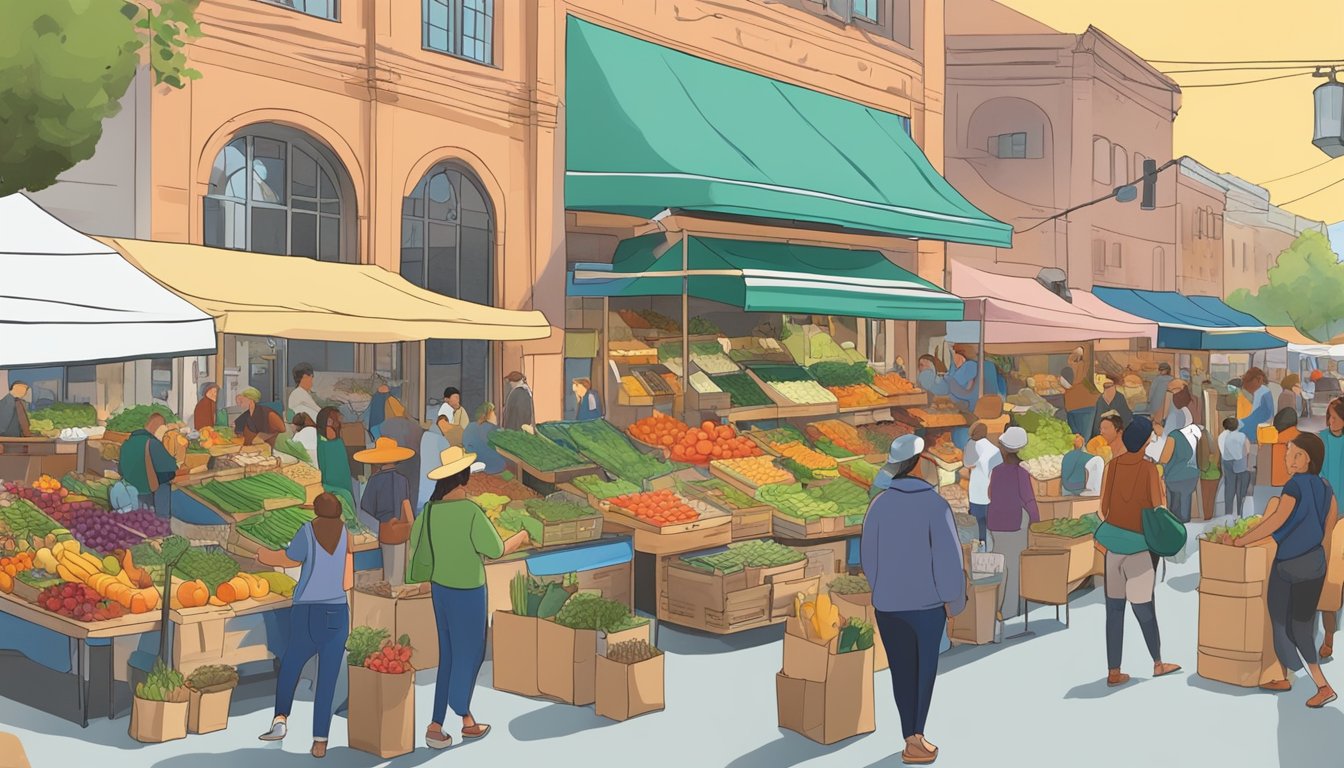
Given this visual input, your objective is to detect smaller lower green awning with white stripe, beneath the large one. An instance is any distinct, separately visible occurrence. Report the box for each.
[569,233,962,320]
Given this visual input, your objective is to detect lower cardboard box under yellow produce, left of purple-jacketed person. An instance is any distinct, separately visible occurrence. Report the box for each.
[774,656,878,744]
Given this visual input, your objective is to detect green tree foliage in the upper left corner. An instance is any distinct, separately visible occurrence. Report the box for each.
[0,0,200,195]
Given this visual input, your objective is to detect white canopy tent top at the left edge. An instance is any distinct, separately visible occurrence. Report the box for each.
[0,195,215,367]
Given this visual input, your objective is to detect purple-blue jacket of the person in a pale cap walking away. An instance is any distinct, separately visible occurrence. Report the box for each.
[859,477,966,615]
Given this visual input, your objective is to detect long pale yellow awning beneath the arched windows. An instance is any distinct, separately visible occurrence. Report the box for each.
[99,238,551,344]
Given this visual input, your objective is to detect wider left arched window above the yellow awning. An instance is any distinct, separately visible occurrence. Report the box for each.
[204,125,355,261]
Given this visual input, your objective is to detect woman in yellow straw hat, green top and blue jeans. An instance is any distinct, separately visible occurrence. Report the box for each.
[406,445,531,749]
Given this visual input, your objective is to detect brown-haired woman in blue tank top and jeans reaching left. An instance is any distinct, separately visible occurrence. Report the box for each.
[257,494,355,757]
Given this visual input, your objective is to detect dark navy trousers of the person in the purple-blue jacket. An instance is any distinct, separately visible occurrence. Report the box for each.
[876,607,948,738]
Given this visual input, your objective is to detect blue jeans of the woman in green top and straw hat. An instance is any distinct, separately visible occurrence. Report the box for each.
[430,584,489,725]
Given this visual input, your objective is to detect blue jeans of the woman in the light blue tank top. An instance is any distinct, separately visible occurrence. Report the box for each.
[276,603,349,738]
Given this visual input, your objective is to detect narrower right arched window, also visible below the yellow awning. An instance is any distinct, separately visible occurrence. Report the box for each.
[401,163,503,410]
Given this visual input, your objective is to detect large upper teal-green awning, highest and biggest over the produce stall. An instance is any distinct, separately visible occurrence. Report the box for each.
[564,16,1012,247]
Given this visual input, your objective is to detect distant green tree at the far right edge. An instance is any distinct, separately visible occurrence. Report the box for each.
[1227,231,1344,342]
